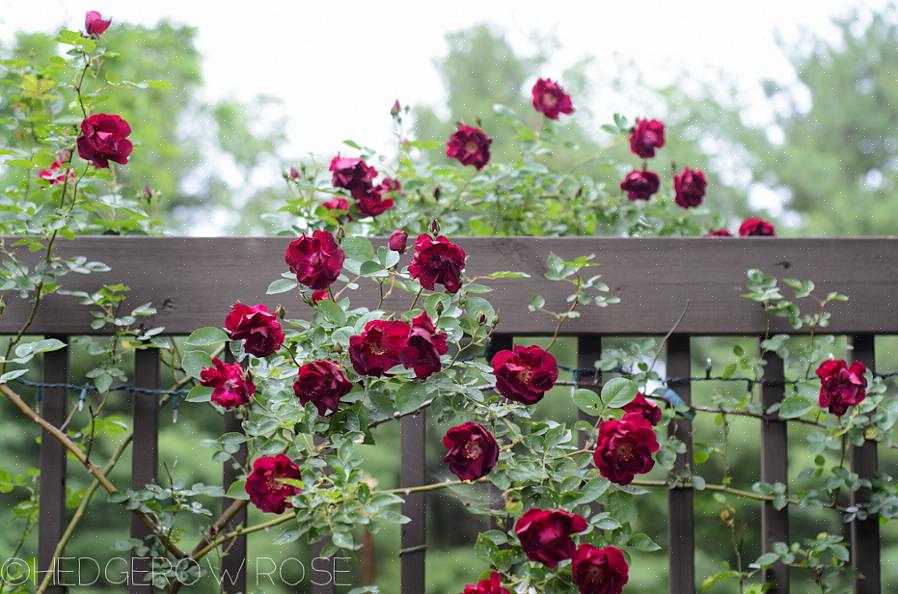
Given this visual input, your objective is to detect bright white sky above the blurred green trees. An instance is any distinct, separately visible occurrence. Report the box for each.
[0,0,885,155]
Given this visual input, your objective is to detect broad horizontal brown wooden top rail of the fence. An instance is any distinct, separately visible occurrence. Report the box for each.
[0,237,898,336]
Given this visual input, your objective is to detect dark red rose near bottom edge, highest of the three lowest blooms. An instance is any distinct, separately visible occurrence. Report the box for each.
[514,508,587,567]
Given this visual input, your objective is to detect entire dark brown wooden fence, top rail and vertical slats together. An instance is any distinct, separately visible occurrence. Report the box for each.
[0,237,898,594]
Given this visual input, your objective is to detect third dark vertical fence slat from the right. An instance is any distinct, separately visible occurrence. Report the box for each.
[667,334,695,594]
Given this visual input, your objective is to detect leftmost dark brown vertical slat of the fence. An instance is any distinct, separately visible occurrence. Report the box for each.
[37,336,69,594]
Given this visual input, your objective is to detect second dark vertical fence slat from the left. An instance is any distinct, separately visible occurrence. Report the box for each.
[129,349,159,594]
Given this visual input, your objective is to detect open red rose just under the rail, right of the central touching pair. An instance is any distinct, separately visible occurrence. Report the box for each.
[492,345,558,404]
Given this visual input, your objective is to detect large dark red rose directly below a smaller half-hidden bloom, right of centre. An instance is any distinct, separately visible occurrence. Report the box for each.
[592,412,660,485]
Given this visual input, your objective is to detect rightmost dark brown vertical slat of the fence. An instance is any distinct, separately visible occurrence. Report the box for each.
[851,334,882,594]
